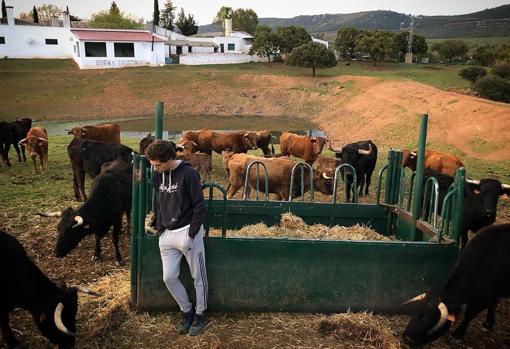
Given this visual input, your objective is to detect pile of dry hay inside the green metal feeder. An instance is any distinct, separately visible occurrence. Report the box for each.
[209,213,391,241]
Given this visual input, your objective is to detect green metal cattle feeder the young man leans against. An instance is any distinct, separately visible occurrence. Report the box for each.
[131,108,463,312]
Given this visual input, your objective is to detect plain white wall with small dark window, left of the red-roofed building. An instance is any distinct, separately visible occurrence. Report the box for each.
[0,24,74,58]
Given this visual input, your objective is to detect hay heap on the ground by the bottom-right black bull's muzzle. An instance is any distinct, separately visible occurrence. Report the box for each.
[319,311,401,349]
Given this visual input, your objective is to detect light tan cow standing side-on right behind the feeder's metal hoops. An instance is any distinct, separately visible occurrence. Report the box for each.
[227,154,333,200]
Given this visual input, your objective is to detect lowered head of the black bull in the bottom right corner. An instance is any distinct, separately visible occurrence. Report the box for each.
[404,293,455,346]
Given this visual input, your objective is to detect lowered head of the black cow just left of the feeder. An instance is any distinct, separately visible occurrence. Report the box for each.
[54,208,90,257]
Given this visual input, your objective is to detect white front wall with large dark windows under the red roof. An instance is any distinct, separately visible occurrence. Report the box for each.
[71,41,165,69]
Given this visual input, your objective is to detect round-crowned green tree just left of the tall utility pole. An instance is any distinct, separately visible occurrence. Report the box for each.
[356,30,395,65]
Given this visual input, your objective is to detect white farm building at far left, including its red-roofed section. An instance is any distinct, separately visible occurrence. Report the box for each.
[0,6,166,69]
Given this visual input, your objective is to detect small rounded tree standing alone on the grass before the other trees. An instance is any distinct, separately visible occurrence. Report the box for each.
[287,42,336,76]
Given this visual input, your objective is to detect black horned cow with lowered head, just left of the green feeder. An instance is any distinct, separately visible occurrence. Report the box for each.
[41,159,131,265]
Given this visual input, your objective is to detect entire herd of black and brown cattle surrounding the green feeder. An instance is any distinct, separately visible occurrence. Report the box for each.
[0,118,510,348]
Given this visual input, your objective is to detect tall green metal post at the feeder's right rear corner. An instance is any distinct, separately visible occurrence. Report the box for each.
[411,114,429,241]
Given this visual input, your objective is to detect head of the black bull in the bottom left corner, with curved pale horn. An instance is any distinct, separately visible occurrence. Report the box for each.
[34,285,78,348]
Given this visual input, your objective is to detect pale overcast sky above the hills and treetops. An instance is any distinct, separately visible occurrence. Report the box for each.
[5,0,509,25]
